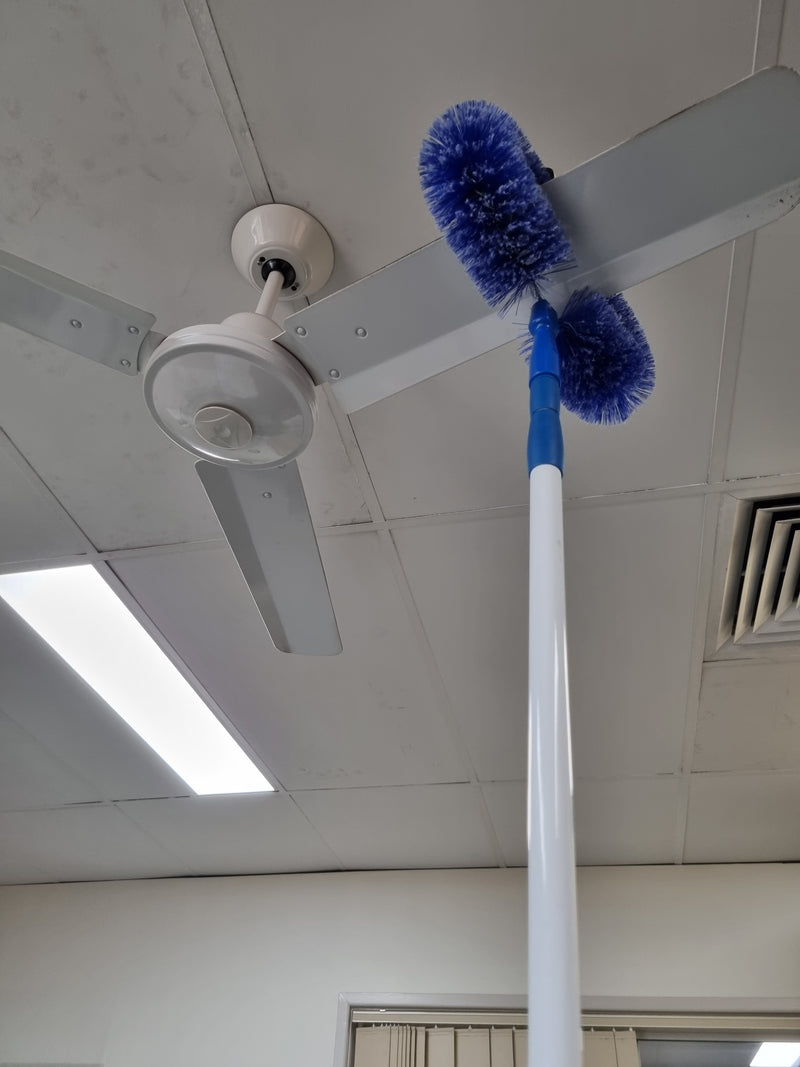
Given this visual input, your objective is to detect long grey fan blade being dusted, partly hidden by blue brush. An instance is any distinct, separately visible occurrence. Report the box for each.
[281,67,800,412]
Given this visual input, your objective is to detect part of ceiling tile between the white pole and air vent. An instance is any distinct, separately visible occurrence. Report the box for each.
[564,497,703,778]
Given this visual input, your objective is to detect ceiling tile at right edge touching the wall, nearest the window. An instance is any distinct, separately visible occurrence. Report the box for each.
[684,774,800,863]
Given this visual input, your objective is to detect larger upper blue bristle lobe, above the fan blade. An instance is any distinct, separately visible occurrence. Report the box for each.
[419,100,571,308]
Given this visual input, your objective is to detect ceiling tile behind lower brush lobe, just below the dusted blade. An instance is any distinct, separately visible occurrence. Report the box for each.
[352,248,731,517]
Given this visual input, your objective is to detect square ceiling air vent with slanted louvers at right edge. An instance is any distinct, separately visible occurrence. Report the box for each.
[717,496,800,648]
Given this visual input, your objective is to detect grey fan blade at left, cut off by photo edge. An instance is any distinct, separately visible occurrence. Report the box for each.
[0,250,156,375]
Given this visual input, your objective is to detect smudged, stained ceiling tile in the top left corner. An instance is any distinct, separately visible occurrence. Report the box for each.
[0,0,255,333]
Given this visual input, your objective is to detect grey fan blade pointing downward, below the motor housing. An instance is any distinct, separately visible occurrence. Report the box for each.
[196,460,341,656]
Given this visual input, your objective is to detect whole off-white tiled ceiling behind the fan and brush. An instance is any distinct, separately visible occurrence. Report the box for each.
[0,0,800,882]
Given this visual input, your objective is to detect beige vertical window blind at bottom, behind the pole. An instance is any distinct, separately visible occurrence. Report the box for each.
[353,1025,640,1067]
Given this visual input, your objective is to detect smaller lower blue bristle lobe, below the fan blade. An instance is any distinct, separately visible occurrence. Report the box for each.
[557,289,656,424]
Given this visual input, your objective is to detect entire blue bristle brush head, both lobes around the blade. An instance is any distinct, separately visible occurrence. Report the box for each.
[419,100,655,423]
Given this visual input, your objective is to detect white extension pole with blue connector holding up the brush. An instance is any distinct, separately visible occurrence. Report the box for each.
[528,300,581,1067]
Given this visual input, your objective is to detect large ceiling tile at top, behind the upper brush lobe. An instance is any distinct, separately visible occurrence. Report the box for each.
[210,0,757,287]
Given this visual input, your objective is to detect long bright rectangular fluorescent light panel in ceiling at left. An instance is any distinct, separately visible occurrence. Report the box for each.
[0,567,273,795]
